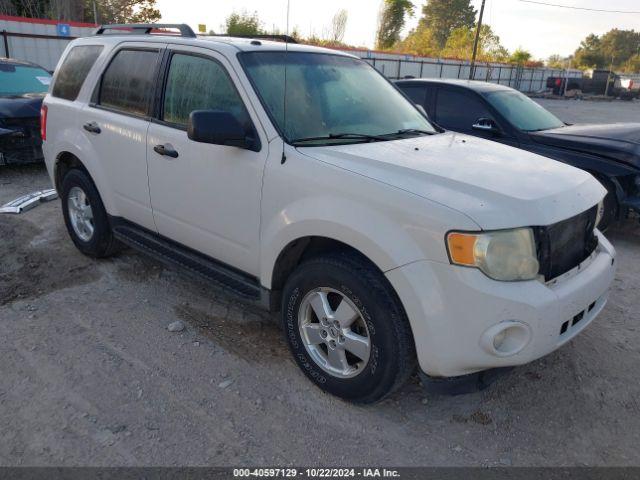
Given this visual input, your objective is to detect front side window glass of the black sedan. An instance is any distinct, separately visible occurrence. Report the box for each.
[436,88,493,132]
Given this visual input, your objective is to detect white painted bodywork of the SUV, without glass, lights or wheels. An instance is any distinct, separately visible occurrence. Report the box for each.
[44,35,615,376]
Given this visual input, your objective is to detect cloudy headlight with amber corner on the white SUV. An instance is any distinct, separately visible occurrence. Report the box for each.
[447,228,540,281]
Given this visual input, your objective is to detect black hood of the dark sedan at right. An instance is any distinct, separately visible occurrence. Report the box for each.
[529,123,640,168]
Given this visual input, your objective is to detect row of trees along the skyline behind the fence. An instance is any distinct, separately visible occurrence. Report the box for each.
[0,0,640,72]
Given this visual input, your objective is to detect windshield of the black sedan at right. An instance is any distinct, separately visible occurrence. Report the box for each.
[485,90,564,132]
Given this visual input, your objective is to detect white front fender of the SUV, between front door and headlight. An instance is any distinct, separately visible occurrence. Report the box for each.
[259,145,480,288]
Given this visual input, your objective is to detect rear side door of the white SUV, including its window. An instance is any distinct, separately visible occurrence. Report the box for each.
[80,42,165,230]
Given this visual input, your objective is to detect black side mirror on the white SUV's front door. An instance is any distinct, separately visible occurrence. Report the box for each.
[187,110,260,151]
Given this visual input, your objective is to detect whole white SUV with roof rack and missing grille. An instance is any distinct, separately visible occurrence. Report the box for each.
[42,25,615,402]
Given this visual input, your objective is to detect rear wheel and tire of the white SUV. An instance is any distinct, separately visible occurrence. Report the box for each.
[60,169,123,258]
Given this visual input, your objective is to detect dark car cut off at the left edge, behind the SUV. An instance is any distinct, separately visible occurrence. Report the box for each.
[0,58,51,165]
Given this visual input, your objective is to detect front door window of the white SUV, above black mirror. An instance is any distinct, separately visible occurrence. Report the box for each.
[162,53,251,128]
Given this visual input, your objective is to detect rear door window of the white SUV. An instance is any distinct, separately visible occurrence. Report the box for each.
[98,50,158,116]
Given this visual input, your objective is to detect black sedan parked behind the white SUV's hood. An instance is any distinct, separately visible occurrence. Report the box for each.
[397,79,640,230]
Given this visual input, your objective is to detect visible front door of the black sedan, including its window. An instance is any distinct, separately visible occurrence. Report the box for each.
[434,86,518,146]
